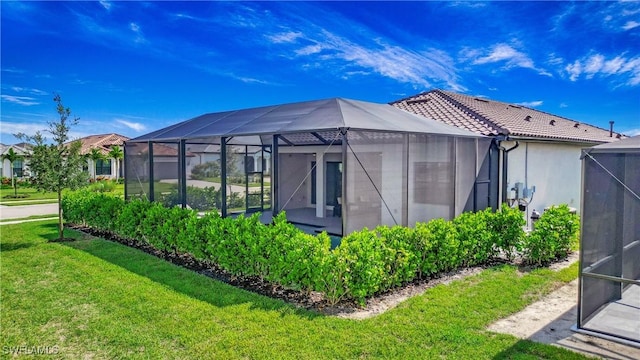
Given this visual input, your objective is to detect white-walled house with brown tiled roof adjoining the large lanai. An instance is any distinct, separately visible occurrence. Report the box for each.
[391,90,624,225]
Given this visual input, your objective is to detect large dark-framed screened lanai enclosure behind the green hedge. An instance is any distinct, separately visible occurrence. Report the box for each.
[125,98,498,236]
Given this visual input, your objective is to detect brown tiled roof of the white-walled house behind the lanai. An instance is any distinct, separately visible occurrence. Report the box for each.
[391,90,623,143]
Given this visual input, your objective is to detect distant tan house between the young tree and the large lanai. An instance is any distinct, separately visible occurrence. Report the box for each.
[77,133,129,179]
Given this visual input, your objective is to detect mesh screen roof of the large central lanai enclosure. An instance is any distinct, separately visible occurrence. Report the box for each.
[127,98,480,144]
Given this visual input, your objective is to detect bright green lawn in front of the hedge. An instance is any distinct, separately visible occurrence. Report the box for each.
[0,221,583,359]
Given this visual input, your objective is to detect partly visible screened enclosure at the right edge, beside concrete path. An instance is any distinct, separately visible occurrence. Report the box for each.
[577,136,640,347]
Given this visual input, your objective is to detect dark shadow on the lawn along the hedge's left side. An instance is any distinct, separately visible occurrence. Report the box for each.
[60,231,323,319]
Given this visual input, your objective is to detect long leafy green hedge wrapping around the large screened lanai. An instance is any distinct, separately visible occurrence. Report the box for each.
[62,191,578,304]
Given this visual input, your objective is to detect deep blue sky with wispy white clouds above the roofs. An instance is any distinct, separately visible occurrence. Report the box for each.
[0,1,640,144]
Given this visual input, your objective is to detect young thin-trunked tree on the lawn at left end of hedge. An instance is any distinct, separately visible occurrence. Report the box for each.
[16,94,88,241]
